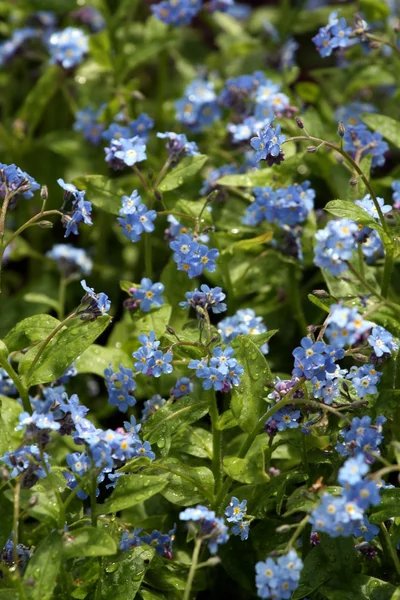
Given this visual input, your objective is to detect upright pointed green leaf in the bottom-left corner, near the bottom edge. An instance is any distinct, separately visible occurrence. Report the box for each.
[24,531,62,600]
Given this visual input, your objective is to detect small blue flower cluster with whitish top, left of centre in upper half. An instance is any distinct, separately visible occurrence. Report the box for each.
[117,190,157,242]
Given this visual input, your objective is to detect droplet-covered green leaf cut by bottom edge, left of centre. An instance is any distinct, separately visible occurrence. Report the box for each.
[100,546,155,600]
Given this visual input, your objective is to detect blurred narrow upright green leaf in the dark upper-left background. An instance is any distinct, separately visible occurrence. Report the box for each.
[17,65,63,135]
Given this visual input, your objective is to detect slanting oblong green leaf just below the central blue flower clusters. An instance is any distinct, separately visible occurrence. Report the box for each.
[143,396,209,444]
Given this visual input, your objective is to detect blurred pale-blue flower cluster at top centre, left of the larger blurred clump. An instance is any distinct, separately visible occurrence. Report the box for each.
[175,79,221,131]
